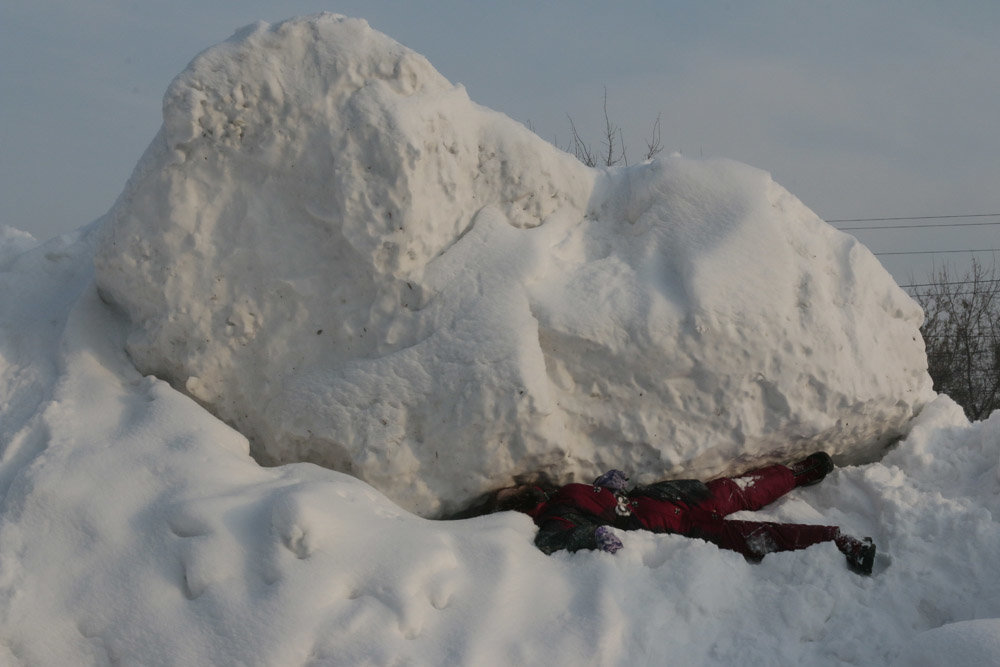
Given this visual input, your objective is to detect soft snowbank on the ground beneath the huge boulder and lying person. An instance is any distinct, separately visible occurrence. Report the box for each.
[0,226,1000,667]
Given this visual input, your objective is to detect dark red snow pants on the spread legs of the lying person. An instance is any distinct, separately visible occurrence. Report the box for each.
[643,465,840,560]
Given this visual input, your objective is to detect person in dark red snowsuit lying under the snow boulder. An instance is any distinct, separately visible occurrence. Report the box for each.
[496,452,875,574]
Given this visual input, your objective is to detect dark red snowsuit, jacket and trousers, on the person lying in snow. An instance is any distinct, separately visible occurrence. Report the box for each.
[529,465,840,560]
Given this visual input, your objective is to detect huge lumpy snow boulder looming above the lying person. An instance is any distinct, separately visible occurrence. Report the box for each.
[96,14,931,516]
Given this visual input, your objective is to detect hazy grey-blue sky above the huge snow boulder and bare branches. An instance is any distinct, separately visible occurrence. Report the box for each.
[0,0,1000,282]
